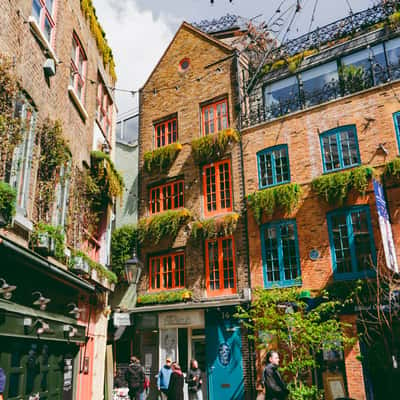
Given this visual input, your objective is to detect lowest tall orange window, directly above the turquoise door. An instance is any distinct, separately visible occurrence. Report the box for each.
[205,236,237,296]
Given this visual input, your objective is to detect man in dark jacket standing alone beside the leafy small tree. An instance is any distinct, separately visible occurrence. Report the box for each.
[264,350,289,400]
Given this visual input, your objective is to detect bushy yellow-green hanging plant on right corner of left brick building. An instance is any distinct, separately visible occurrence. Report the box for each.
[90,150,124,210]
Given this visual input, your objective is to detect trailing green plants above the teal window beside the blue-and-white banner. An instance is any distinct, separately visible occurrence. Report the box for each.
[311,166,375,205]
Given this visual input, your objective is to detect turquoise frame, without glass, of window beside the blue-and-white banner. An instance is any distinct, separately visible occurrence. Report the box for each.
[327,205,376,280]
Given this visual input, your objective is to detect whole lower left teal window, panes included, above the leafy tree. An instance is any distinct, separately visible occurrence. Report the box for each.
[261,220,301,287]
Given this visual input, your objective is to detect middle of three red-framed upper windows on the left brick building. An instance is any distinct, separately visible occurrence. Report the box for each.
[70,33,87,104]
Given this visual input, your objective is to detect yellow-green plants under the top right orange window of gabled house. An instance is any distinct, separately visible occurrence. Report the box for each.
[192,128,240,164]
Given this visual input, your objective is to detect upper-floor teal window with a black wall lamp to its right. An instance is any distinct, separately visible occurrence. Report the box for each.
[320,125,360,172]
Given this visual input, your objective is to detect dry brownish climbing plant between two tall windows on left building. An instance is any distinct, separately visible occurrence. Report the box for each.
[36,119,71,221]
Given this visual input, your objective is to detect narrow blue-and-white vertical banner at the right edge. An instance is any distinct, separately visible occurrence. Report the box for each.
[373,179,399,272]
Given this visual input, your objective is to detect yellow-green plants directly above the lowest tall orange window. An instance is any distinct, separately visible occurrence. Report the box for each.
[191,213,239,239]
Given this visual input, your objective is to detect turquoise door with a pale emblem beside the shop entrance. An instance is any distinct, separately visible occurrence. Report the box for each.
[206,310,244,400]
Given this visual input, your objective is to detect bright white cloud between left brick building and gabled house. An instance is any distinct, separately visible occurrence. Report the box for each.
[94,0,174,113]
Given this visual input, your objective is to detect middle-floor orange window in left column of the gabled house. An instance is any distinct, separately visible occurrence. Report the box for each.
[149,180,185,215]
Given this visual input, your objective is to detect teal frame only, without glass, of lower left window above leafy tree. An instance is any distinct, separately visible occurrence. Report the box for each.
[261,219,302,288]
